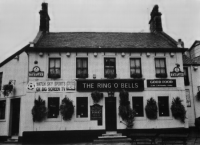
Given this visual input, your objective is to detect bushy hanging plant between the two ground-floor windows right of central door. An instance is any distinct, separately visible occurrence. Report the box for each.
[145,98,158,120]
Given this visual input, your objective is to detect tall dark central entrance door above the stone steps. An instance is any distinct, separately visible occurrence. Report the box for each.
[105,97,117,131]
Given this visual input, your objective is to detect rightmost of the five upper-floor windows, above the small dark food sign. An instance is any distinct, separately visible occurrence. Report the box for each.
[155,58,167,78]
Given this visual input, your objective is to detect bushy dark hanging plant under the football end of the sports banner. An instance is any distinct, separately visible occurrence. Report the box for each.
[32,96,47,122]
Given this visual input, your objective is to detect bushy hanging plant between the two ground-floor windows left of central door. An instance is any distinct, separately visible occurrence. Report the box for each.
[60,97,74,121]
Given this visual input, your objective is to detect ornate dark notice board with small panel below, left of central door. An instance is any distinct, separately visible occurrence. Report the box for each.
[90,104,102,125]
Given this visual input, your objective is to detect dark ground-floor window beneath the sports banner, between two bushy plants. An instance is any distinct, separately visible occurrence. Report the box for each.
[48,97,60,118]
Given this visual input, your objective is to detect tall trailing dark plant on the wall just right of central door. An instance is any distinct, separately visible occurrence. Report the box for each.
[119,90,136,129]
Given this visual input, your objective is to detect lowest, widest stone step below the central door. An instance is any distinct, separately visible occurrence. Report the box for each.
[93,138,131,144]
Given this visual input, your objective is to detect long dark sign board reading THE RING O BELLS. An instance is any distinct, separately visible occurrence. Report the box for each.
[77,79,144,92]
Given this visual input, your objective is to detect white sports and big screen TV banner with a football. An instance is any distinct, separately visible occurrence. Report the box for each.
[27,80,76,92]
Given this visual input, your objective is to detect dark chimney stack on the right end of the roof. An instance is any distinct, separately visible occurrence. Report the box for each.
[149,5,163,32]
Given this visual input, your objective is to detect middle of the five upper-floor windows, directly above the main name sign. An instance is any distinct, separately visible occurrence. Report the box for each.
[104,58,116,78]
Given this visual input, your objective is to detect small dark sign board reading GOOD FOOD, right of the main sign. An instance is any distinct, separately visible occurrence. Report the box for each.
[147,79,176,87]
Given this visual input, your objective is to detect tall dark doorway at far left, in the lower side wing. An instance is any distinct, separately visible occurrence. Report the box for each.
[10,98,20,136]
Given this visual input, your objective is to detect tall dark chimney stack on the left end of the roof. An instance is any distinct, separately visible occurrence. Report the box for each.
[39,3,50,32]
